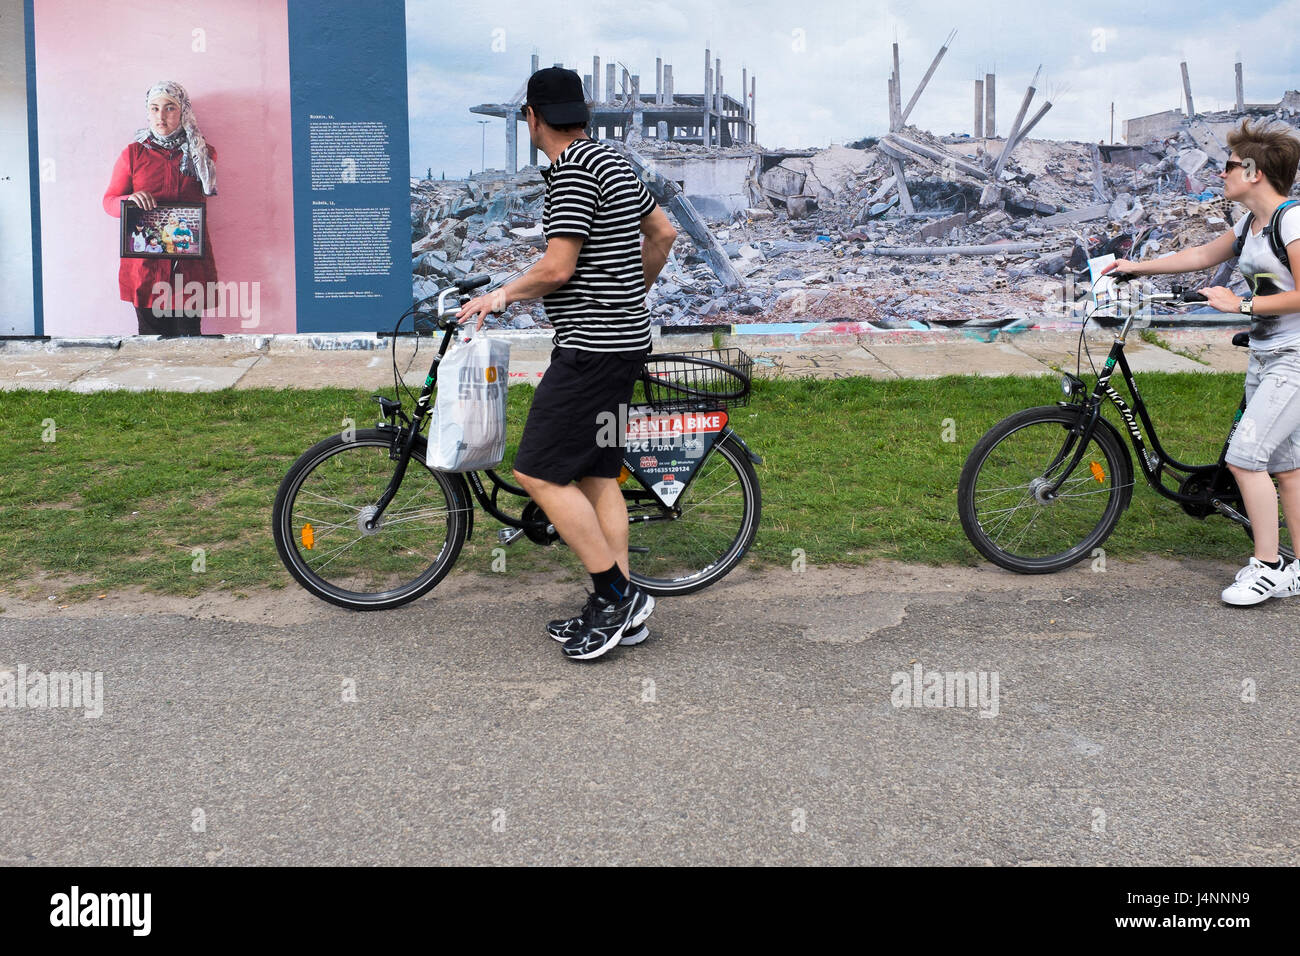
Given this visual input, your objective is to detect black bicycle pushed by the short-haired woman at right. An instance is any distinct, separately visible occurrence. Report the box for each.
[957,273,1295,574]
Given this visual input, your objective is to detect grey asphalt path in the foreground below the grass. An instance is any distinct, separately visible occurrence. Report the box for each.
[0,561,1300,865]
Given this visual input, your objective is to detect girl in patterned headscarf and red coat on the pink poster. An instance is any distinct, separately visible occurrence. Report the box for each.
[104,81,217,336]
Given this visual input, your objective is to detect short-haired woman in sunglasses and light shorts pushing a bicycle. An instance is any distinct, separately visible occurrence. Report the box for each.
[1102,120,1300,606]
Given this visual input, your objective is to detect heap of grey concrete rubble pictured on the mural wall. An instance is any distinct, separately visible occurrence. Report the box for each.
[411,101,1294,329]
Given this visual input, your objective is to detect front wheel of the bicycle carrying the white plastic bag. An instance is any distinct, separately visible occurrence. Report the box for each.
[272,428,469,610]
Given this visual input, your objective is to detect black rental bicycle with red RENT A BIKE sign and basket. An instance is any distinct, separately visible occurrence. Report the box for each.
[272,276,763,610]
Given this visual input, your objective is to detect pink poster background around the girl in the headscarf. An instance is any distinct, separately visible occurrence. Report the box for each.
[34,0,296,337]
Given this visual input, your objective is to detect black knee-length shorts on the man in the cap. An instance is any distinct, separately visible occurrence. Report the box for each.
[515,346,650,485]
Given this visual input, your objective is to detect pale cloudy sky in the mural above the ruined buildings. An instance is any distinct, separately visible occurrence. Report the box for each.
[407,0,1300,178]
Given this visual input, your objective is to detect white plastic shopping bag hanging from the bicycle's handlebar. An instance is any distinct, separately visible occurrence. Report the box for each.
[426,336,510,471]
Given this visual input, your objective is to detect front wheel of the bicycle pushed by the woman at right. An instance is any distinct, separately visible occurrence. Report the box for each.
[957,406,1132,574]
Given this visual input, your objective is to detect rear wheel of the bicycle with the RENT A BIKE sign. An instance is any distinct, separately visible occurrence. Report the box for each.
[628,436,762,594]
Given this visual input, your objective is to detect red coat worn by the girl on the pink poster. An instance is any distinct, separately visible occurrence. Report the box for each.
[104,143,217,307]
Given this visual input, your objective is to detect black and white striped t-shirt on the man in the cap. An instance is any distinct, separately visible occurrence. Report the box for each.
[542,138,655,351]
